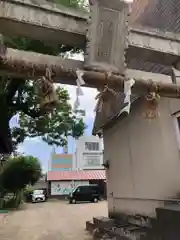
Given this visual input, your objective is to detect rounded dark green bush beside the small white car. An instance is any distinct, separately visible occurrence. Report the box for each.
[0,156,41,192]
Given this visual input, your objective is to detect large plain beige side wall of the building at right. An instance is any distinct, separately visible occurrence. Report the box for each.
[103,99,180,216]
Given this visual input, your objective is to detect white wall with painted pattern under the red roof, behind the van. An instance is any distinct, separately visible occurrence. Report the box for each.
[51,181,89,196]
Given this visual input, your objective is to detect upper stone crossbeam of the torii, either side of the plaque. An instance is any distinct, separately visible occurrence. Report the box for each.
[0,0,180,68]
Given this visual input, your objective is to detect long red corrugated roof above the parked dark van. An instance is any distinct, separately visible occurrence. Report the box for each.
[47,170,106,181]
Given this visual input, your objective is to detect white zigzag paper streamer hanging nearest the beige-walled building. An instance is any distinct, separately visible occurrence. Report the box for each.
[119,78,135,115]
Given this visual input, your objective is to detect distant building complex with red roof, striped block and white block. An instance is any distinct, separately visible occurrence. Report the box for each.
[47,136,106,197]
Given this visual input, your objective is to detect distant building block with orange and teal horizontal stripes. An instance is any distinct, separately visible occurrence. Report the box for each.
[49,151,73,171]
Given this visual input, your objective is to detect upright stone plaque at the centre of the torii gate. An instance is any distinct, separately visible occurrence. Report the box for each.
[85,0,129,74]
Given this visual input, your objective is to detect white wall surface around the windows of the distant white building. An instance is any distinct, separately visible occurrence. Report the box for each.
[73,136,103,169]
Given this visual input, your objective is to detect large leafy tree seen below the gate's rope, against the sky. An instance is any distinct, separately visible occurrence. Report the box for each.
[0,75,85,150]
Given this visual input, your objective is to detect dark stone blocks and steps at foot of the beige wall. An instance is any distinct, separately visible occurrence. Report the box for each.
[86,205,180,240]
